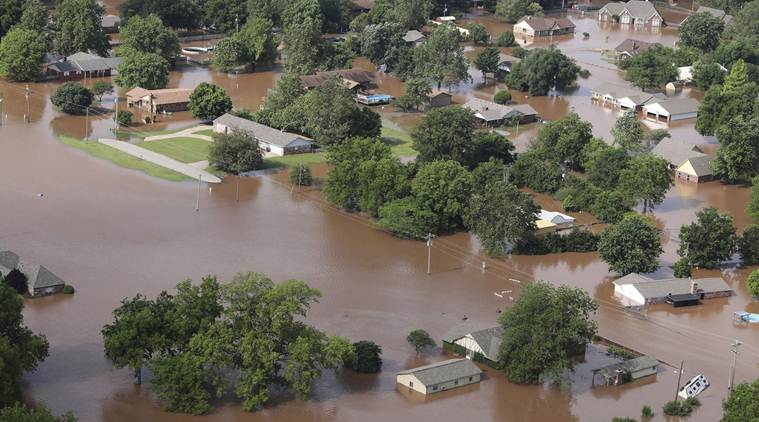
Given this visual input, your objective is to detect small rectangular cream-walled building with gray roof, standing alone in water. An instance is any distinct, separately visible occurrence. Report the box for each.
[395,358,482,395]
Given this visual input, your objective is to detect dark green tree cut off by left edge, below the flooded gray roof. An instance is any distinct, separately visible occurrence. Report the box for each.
[0,283,48,408]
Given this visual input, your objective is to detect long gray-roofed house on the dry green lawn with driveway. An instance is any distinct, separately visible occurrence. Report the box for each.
[213,113,314,156]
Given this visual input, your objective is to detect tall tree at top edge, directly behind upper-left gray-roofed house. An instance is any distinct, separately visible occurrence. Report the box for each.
[54,0,111,56]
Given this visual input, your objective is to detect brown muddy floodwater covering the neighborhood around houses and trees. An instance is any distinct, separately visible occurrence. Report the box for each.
[0,9,759,422]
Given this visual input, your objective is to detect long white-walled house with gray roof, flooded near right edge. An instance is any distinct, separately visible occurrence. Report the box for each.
[614,273,733,306]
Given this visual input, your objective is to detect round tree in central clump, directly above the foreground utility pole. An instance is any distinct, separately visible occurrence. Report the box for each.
[411,160,472,232]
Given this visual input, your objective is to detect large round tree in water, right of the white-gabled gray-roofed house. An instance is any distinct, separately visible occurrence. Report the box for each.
[498,281,598,384]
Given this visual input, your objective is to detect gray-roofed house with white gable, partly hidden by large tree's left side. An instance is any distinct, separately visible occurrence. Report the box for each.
[442,323,503,367]
